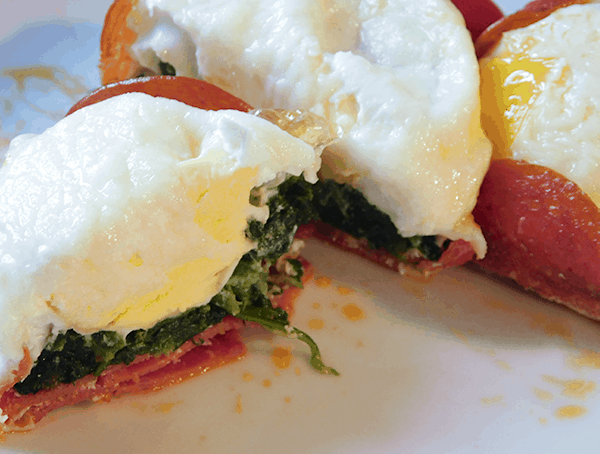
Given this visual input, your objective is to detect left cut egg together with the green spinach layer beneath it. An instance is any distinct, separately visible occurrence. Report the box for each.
[0,93,334,430]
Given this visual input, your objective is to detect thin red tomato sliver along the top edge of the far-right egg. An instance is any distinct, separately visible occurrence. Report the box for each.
[475,0,597,58]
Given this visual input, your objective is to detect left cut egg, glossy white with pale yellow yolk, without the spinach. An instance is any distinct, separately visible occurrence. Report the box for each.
[0,93,320,384]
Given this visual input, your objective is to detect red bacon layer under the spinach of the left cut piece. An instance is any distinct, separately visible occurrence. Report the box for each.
[0,258,314,434]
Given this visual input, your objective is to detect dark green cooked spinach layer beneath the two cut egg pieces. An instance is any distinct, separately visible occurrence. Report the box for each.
[15,173,444,394]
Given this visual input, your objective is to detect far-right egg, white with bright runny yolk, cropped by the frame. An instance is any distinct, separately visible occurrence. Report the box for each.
[481,4,600,206]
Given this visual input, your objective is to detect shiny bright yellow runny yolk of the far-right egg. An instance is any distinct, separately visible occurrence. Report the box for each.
[481,55,554,159]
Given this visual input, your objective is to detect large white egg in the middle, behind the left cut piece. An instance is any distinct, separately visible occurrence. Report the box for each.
[128,0,491,261]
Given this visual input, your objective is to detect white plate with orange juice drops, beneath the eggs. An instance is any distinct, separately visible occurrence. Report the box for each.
[0,0,600,454]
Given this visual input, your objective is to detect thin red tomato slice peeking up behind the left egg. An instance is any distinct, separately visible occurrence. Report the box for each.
[67,76,252,115]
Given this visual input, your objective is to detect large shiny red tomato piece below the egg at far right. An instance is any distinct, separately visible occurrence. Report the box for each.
[473,159,600,319]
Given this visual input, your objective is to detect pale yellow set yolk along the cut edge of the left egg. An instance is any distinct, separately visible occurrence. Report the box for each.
[50,168,257,330]
